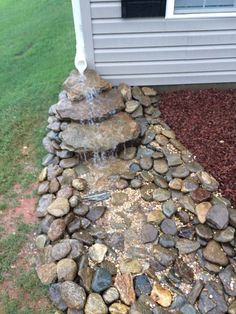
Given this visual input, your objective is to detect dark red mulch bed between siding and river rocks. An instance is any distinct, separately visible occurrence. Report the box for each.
[160,89,236,206]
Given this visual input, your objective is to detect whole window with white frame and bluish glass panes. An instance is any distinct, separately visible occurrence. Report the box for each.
[166,0,236,18]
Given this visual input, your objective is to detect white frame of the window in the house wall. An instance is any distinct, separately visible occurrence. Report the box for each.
[165,0,236,19]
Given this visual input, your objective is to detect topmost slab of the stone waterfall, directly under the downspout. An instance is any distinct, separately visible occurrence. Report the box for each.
[63,70,112,101]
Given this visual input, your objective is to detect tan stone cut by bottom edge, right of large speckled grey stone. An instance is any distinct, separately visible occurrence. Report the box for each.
[84,293,108,314]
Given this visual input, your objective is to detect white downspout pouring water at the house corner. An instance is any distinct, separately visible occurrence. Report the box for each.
[71,0,88,75]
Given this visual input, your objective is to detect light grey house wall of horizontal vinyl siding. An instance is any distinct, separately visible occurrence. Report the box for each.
[81,0,236,85]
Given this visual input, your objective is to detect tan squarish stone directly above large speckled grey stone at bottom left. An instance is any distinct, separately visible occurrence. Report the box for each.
[57,258,77,281]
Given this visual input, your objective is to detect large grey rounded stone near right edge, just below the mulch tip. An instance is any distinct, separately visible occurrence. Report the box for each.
[206,205,229,230]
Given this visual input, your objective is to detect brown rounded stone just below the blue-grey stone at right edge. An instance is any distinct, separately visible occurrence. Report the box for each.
[203,240,229,266]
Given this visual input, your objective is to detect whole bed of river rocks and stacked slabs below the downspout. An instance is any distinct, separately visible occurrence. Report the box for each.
[36,72,236,314]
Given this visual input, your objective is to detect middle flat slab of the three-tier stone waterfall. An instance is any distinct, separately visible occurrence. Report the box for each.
[56,89,125,123]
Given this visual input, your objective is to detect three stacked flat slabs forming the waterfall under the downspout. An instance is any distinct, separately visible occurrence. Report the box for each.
[45,70,139,162]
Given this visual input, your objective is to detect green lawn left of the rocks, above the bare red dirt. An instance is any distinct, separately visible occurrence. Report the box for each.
[0,0,75,195]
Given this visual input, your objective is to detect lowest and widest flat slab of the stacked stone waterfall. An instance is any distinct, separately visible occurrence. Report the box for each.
[61,112,139,152]
